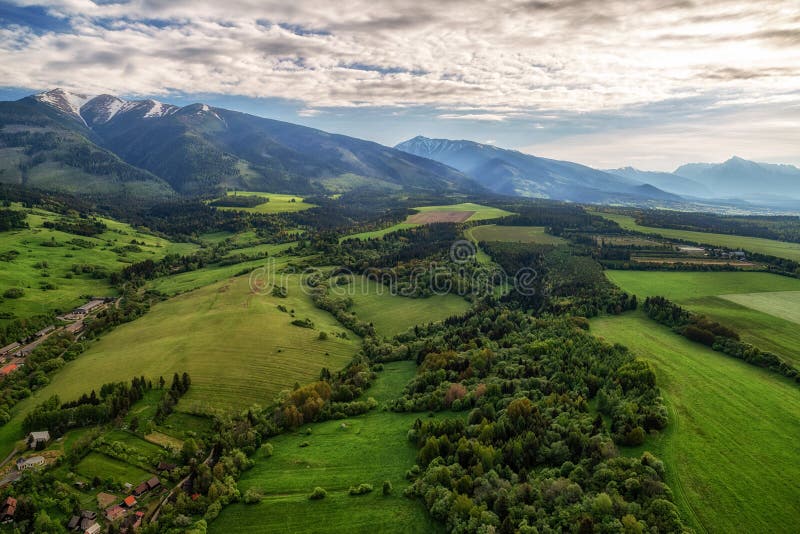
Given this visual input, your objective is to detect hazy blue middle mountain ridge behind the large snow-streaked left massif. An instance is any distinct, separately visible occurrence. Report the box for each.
[395,136,681,202]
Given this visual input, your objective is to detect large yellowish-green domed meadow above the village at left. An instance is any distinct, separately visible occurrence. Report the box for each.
[0,275,359,455]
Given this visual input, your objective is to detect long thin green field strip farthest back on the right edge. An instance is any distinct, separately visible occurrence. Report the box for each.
[594,212,800,261]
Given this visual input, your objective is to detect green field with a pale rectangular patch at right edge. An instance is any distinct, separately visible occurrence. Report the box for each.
[606,271,800,365]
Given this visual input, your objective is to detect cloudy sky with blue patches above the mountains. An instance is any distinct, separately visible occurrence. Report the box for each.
[0,0,800,171]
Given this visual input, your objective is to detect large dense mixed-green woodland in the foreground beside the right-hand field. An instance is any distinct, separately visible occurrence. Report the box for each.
[366,305,682,532]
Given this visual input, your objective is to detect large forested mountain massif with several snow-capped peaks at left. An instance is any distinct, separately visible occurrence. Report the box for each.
[0,89,483,198]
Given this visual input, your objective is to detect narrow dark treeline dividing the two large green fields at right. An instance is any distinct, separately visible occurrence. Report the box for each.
[643,297,800,383]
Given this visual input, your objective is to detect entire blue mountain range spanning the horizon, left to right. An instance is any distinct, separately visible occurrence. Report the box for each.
[0,89,800,206]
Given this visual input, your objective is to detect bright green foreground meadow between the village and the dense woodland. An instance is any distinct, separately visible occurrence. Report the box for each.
[209,362,442,534]
